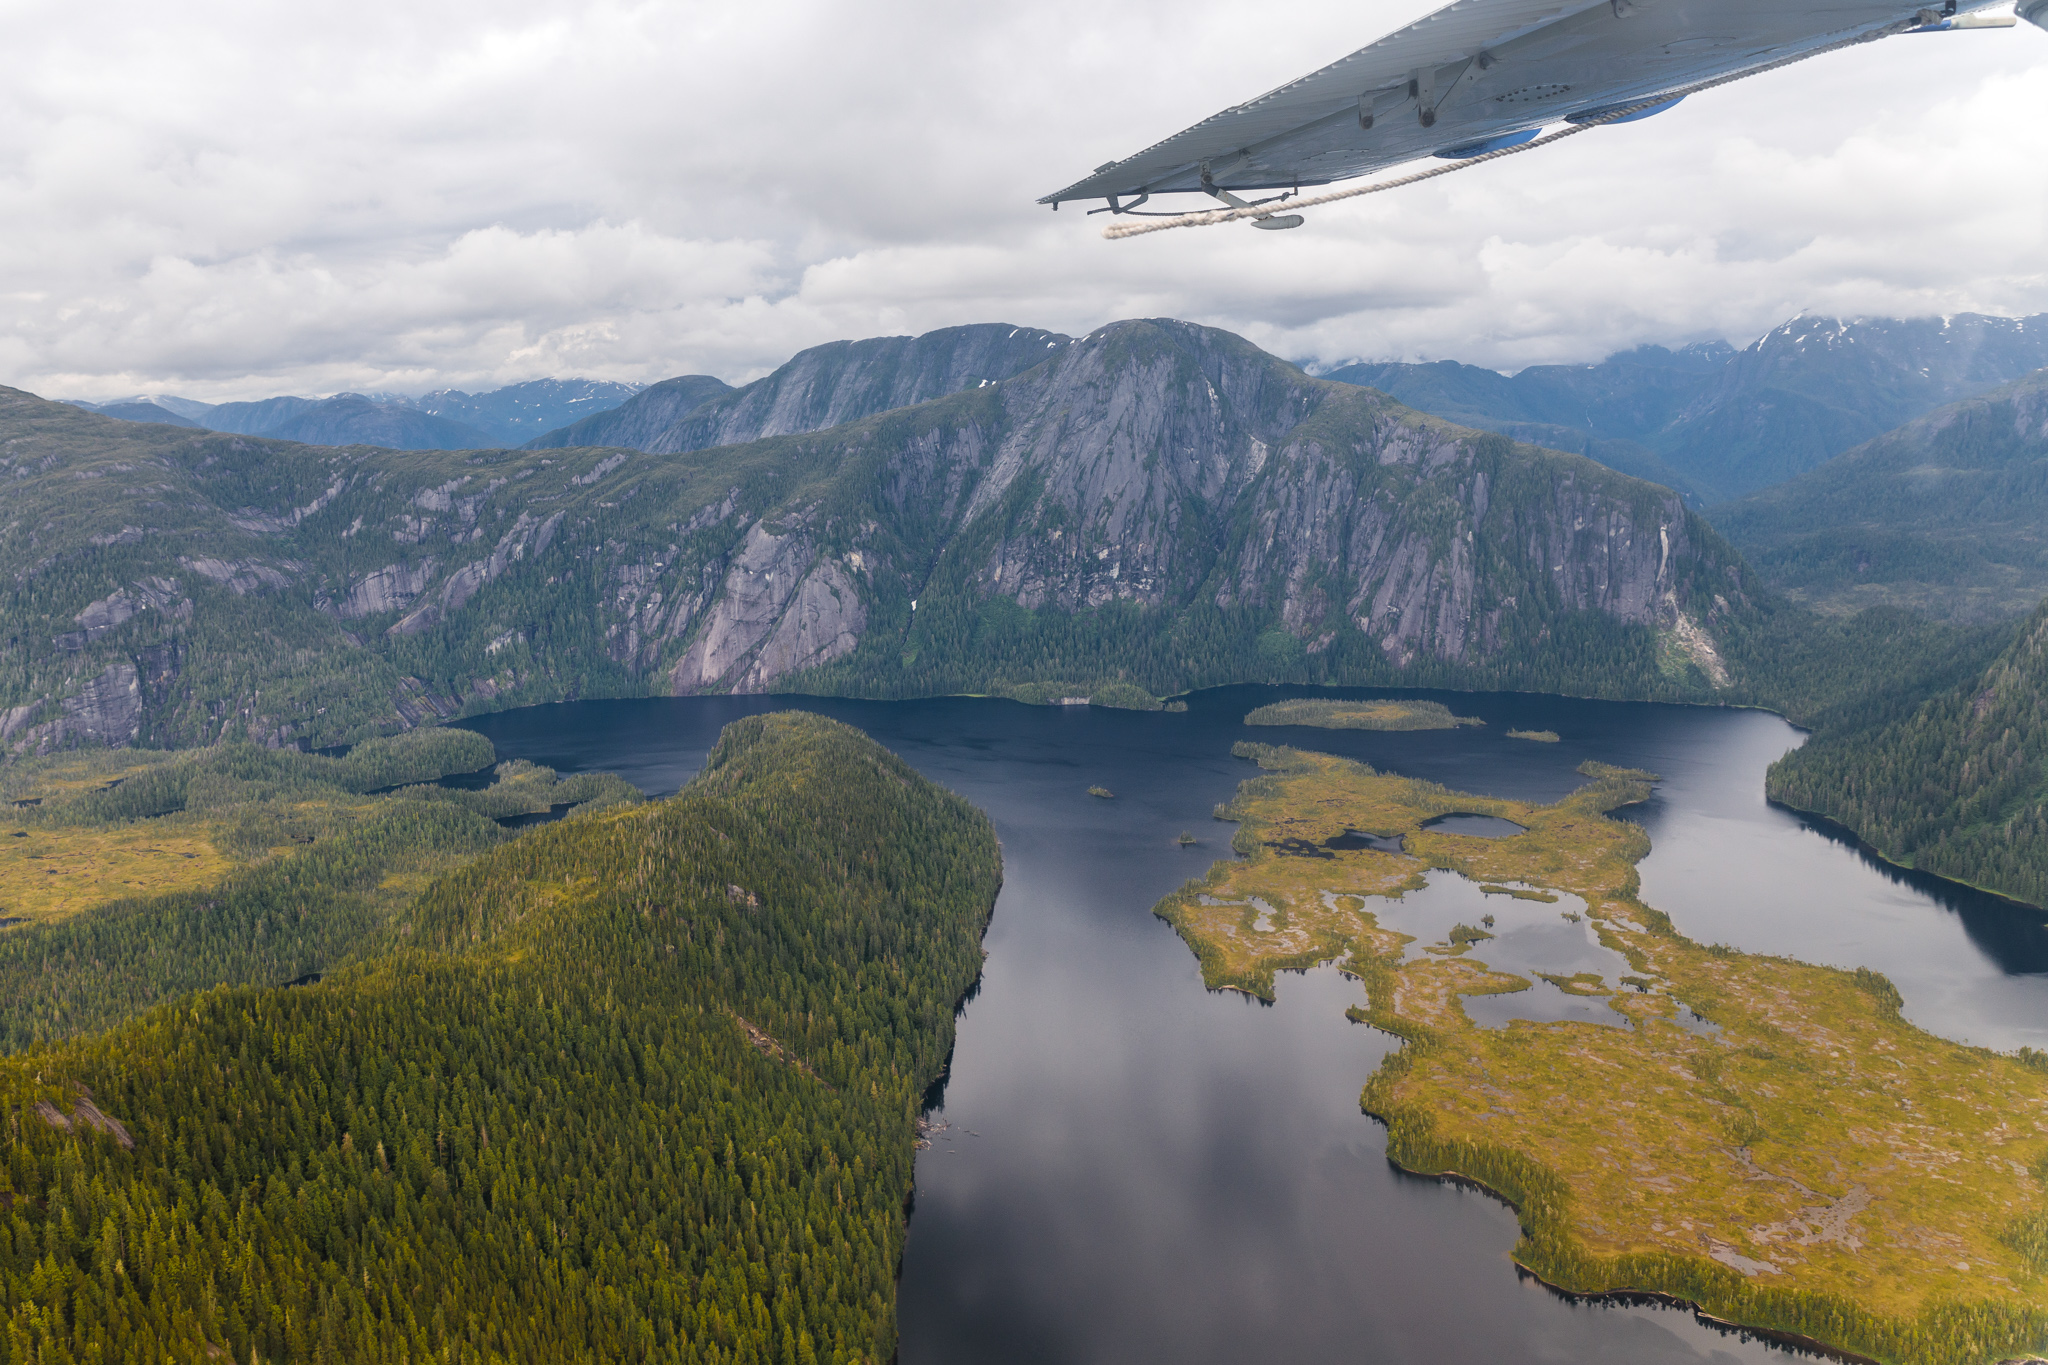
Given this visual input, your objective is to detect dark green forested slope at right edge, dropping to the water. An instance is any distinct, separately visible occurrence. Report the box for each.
[1769,608,2048,905]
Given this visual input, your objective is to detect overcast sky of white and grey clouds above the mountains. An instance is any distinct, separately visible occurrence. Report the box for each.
[0,0,2048,401]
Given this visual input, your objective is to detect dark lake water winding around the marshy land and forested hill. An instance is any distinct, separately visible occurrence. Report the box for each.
[469,688,2048,1365]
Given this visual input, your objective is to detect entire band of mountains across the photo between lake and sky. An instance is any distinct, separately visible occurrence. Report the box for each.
[16,317,2048,908]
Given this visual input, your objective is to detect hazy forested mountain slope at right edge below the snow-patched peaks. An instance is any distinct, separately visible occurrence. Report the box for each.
[1712,370,2048,620]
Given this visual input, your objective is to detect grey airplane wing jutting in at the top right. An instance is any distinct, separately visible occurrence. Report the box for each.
[1038,0,2040,213]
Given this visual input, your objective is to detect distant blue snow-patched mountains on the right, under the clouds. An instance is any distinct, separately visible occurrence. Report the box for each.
[1325,313,2048,505]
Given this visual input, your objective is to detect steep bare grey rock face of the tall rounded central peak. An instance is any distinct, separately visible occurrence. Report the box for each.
[860,323,1728,679]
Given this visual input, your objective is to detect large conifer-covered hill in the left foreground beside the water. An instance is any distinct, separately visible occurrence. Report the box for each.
[0,714,999,1365]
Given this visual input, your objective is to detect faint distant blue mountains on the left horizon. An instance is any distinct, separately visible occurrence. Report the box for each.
[76,379,638,450]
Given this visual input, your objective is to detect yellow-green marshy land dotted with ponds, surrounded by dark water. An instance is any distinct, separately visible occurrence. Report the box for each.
[1157,745,2048,1365]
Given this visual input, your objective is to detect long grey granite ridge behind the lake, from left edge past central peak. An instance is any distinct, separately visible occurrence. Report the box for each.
[0,321,1755,751]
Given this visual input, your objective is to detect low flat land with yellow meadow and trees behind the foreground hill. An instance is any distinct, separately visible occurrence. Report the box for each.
[0,729,639,1050]
